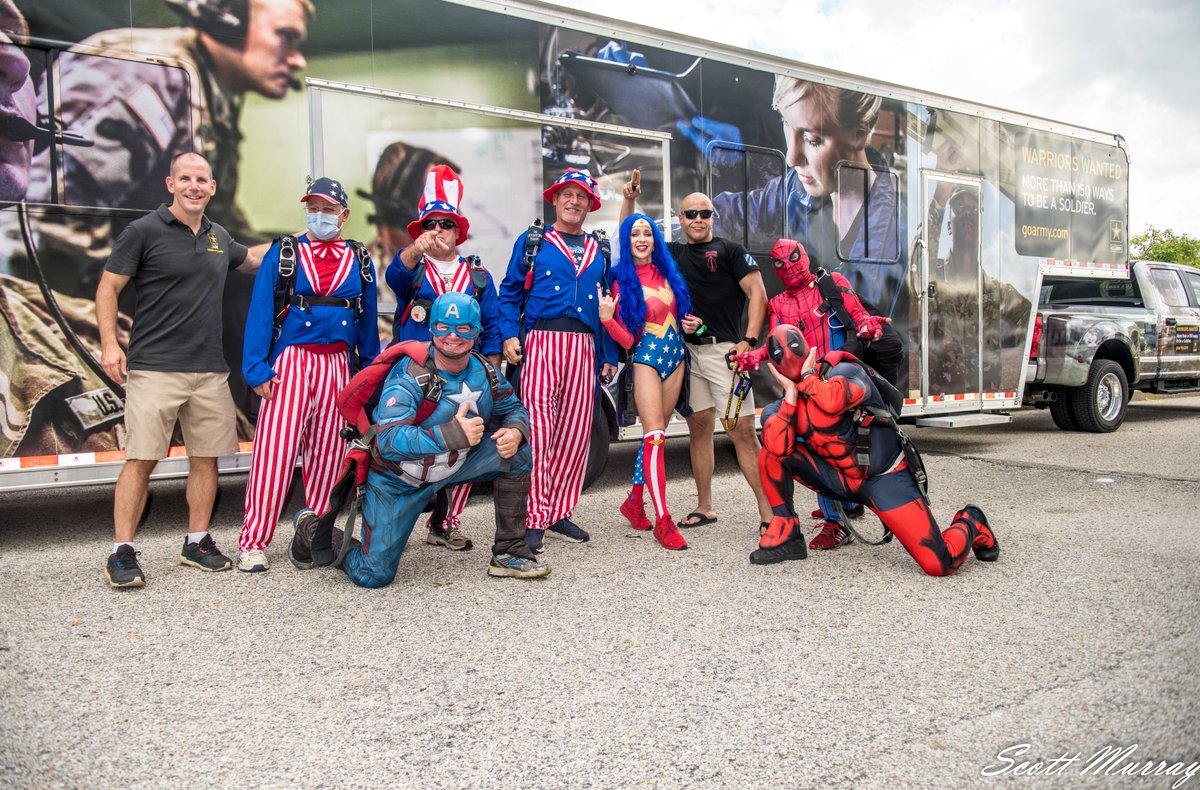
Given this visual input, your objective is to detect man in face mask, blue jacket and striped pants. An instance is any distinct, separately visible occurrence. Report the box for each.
[238,178,379,571]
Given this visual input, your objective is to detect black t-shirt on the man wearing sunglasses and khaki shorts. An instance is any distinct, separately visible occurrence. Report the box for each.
[667,237,760,343]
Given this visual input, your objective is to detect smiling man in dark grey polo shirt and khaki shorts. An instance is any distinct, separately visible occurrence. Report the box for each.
[96,154,264,587]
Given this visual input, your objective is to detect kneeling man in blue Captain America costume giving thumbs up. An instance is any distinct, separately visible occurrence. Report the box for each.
[289,292,550,587]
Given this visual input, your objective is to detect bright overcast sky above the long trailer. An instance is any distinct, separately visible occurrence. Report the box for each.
[542,0,1200,237]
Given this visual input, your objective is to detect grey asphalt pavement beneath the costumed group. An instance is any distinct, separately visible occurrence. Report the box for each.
[0,396,1200,788]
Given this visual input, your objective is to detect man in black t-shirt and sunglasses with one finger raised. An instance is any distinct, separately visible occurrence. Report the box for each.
[620,169,770,527]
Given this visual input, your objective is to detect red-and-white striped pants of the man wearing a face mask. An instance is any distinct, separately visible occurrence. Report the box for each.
[238,346,350,550]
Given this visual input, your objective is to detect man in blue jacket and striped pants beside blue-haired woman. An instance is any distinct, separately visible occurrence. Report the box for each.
[500,169,617,552]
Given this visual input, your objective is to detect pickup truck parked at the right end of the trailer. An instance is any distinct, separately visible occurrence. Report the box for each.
[1024,261,1200,433]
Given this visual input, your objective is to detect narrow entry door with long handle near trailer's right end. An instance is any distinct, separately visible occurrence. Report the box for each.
[920,173,983,411]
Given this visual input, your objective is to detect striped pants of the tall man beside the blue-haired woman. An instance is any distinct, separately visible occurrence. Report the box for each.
[521,329,596,529]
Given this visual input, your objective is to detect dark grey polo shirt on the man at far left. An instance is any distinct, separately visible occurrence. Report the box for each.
[104,204,246,372]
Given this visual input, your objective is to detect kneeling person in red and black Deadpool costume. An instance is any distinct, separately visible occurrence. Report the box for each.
[750,325,1000,576]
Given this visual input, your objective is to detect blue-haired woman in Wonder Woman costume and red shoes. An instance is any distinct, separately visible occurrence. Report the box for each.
[598,214,691,550]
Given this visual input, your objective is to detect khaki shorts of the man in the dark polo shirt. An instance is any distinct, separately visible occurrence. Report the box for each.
[125,370,238,461]
